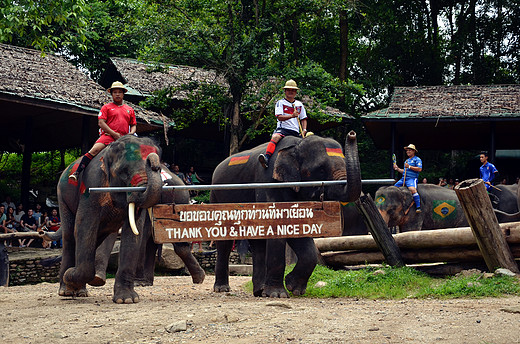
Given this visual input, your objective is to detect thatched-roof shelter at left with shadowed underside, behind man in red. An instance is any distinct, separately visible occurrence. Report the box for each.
[0,44,167,150]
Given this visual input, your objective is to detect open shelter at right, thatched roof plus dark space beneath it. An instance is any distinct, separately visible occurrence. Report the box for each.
[361,85,520,151]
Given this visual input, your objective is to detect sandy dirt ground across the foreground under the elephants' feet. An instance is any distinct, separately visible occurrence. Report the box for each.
[0,276,520,344]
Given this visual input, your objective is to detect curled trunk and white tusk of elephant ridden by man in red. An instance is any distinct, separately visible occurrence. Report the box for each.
[128,153,162,235]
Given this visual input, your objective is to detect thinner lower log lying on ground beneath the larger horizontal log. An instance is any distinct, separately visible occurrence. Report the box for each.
[321,244,520,271]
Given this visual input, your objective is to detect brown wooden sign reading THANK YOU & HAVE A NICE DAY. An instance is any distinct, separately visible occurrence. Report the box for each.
[152,202,343,244]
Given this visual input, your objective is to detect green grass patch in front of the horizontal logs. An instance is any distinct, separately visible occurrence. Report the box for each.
[247,265,520,299]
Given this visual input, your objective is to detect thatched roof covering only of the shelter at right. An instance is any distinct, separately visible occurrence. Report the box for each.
[363,85,520,119]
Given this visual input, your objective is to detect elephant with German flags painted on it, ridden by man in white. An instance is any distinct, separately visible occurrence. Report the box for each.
[210,131,361,297]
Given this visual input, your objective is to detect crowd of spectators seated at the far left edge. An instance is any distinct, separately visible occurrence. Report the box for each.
[0,196,61,248]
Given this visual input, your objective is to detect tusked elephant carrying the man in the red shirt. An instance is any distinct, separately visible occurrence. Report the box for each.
[57,135,168,303]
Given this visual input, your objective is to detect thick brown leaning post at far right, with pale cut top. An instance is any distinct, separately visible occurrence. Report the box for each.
[455,179,520,274]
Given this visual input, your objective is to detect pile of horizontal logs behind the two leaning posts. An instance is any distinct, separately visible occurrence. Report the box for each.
[314,222,520,267]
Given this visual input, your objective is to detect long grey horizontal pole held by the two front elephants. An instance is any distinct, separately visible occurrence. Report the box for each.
[89,179,395,192]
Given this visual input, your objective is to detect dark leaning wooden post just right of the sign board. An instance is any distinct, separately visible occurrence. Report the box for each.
[356,195,405,266]
